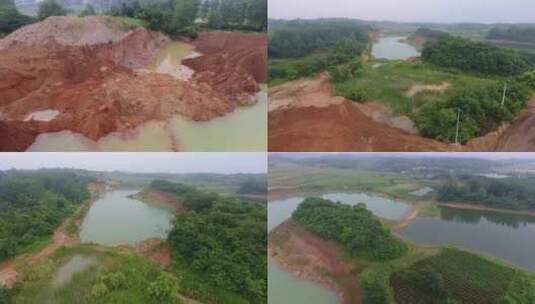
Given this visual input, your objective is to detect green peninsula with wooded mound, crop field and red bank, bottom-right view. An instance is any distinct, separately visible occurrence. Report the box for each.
[269,198,535,304]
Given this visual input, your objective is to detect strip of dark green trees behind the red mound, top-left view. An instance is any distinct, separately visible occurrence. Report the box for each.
[0,0,267,37]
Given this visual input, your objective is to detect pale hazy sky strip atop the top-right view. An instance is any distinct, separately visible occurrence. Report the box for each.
[268,0,535,23]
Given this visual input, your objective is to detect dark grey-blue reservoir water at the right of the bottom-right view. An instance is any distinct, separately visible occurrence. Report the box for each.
[400,208,535,270]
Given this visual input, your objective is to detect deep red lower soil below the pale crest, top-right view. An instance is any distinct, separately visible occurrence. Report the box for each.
[268,101,451,152]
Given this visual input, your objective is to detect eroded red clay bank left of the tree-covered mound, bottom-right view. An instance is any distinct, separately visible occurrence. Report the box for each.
[268,220,362,304]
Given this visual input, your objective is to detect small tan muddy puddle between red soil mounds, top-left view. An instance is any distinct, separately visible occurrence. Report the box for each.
[148,42,200,81]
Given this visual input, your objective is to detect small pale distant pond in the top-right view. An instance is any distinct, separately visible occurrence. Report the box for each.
[372,36,420,60]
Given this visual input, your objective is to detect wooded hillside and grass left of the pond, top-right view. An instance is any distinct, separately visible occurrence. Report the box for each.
[268,20,369,85]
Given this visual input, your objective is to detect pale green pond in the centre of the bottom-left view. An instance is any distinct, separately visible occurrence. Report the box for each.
[80,190,174,245]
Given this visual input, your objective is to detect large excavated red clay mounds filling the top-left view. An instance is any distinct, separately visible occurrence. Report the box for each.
[0,17,266,151]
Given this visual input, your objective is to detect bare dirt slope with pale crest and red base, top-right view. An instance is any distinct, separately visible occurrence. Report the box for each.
[268,75,452,152]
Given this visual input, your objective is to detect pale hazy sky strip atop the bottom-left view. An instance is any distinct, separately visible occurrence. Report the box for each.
[0,152,267,173]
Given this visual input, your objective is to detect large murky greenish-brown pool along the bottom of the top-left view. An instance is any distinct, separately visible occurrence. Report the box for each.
[27,90,267,152]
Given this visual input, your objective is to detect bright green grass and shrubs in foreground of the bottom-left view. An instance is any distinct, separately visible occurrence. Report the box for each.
[12,245,182,304]
